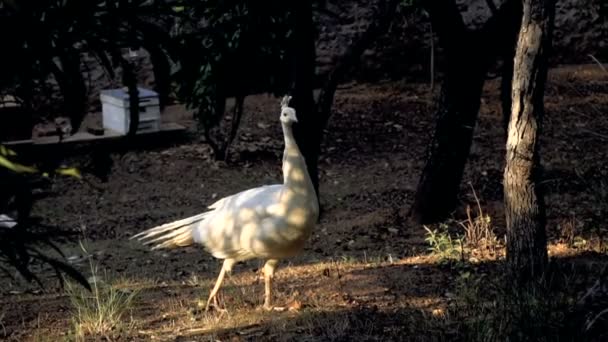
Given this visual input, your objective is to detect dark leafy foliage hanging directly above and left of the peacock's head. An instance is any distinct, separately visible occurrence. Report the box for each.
[176,0,291,159]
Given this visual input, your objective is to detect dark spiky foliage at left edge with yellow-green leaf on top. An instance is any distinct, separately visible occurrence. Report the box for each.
[0,146,90,288]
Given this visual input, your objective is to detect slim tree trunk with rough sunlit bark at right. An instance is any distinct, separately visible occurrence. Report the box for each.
[504,0,555,281]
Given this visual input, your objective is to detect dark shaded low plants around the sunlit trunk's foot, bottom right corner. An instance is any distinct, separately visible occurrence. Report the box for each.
[450,267,606,341]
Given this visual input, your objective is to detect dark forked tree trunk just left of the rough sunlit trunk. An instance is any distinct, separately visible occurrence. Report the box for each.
[410,0,521,224]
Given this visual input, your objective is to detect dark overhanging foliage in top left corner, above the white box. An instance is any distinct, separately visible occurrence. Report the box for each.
[0,0,180,131]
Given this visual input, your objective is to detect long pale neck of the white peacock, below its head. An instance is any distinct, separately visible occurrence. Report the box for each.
[282,123,316,196]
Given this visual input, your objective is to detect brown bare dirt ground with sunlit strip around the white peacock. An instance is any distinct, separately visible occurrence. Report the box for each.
[0,66,608,341]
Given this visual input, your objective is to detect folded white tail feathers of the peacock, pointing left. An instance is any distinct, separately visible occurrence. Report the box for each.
[130,211,211,250]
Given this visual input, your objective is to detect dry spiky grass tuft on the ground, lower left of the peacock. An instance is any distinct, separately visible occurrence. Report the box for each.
[66,244,139,340]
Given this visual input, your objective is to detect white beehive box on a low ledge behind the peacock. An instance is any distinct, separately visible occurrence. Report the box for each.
[99,88,160,134]
